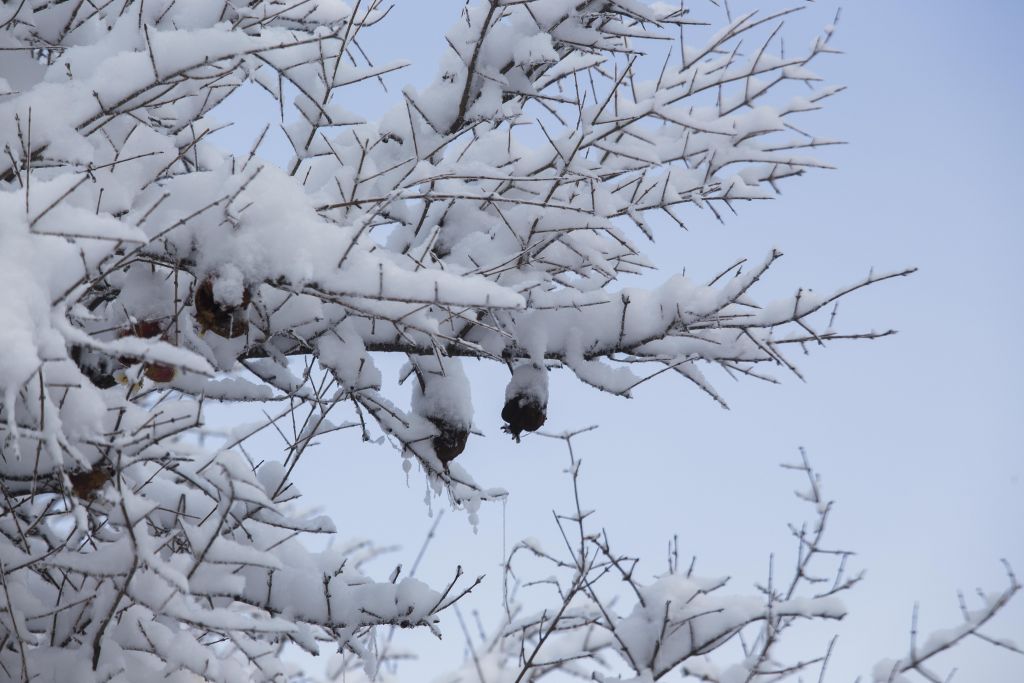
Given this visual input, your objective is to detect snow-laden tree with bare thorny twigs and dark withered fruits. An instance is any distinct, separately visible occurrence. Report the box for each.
[0,0,1019,681]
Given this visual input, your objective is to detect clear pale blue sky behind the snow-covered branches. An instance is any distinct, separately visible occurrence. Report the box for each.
[209,0,1024,683]
